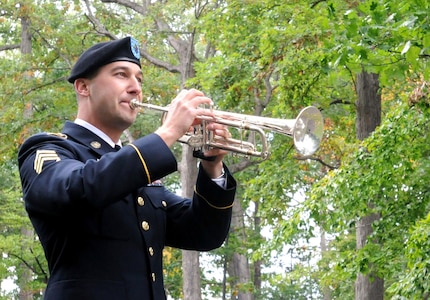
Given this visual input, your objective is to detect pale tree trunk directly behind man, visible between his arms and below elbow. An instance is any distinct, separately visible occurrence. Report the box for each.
[180,145,202,300]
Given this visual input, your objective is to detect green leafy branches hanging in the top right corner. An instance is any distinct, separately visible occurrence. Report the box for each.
[325,0,429,85]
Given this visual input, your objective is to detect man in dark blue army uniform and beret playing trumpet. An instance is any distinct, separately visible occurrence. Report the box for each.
[18,37,236,300]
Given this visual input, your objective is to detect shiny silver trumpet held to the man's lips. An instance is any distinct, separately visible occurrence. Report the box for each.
[130,99,324,160]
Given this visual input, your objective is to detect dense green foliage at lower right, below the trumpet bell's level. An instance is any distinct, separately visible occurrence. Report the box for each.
[311,101,430,298]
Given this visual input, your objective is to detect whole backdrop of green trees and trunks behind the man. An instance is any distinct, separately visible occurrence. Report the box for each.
[0,0,430,300]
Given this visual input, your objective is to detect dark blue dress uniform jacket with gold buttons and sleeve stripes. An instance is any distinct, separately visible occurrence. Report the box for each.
[18,122,236,300]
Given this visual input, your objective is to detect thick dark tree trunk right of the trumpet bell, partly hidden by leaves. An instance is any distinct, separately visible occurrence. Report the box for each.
[355,71,384,300]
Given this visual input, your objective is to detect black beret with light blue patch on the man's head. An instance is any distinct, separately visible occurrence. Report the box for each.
[67,37,141,83]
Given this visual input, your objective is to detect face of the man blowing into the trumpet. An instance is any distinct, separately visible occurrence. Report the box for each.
[86,61,142,132]
